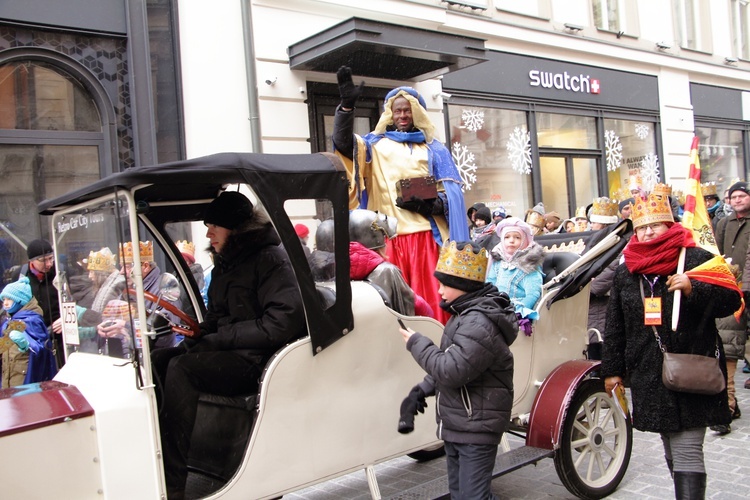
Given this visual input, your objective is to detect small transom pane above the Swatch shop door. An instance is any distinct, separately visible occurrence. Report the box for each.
[536,113,599,149]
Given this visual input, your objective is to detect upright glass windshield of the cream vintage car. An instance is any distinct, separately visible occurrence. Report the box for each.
[53,192,151,359]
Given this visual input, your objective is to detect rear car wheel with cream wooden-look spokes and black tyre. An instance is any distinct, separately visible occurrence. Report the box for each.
[555,379,633,499]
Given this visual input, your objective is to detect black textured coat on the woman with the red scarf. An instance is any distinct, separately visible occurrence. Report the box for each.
[601,248,740,432]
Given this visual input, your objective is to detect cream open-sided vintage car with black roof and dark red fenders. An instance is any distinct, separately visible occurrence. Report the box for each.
[0,153,632,499]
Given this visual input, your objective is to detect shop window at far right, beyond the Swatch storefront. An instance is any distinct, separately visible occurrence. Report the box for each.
[695,127,746,196]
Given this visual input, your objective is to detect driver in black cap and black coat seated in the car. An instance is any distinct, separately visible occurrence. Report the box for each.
[152,191,307,500]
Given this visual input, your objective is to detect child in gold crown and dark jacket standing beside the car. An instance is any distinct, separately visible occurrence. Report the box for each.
[398,242,518,499]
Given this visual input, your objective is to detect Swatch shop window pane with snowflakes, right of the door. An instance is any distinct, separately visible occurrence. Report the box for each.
[604,119,662,200]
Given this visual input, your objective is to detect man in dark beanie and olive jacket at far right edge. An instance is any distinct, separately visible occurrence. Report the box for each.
[711,181,750,434]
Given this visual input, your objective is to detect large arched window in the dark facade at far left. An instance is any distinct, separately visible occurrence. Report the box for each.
[0,60,104,272]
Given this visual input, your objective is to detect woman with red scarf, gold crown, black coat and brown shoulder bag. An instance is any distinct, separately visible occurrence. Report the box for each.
[601,188,741,499]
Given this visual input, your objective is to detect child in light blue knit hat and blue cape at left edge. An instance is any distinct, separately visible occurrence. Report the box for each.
[0,276,57,389]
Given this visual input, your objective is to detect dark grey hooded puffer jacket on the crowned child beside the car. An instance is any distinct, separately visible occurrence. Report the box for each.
[406,284,518,444]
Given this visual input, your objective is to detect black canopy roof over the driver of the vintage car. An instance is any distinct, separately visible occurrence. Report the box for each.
[39,153,353,352]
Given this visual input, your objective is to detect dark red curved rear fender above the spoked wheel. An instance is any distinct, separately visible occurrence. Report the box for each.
[526,359,601,450]
